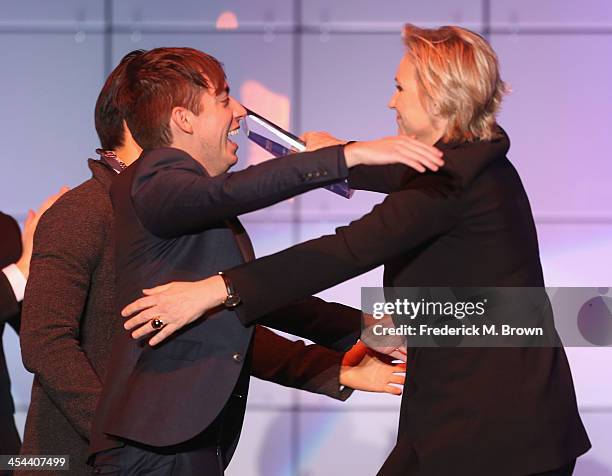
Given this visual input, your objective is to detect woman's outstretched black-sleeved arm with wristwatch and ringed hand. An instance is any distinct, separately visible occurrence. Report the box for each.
[122,176,458,345]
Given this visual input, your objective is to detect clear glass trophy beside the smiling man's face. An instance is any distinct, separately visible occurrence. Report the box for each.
[240,108,355,198]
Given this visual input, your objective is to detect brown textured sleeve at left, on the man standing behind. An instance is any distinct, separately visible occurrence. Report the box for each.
[21,192,110,440]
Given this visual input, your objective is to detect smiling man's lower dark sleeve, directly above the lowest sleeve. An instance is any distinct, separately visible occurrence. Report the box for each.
[260,297,361,352]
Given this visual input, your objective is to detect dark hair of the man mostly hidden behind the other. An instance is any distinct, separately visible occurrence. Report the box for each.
[94,50,145,150]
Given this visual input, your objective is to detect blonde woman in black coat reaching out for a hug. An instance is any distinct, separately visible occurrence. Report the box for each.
[124,25,590,476]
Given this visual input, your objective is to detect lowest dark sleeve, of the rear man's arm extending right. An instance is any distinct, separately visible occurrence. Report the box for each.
[251,326,352,400]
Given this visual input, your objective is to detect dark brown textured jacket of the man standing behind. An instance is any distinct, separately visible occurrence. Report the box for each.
[21,160,359,475]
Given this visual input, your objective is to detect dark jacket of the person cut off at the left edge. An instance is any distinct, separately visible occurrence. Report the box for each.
[0,213,21,420]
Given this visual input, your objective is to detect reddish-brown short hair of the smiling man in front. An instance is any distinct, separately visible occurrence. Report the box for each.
[120,48,226,149]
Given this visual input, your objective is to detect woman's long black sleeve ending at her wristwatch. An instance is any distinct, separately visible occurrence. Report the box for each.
[225,176,458,325]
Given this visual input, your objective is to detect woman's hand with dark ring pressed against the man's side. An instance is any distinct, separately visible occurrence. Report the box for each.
[121,276,227,345]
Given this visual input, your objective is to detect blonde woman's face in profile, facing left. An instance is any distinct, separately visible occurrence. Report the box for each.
[389,54,441,144]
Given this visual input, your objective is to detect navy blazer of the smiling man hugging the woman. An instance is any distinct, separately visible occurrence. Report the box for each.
[91,147,359,464]
